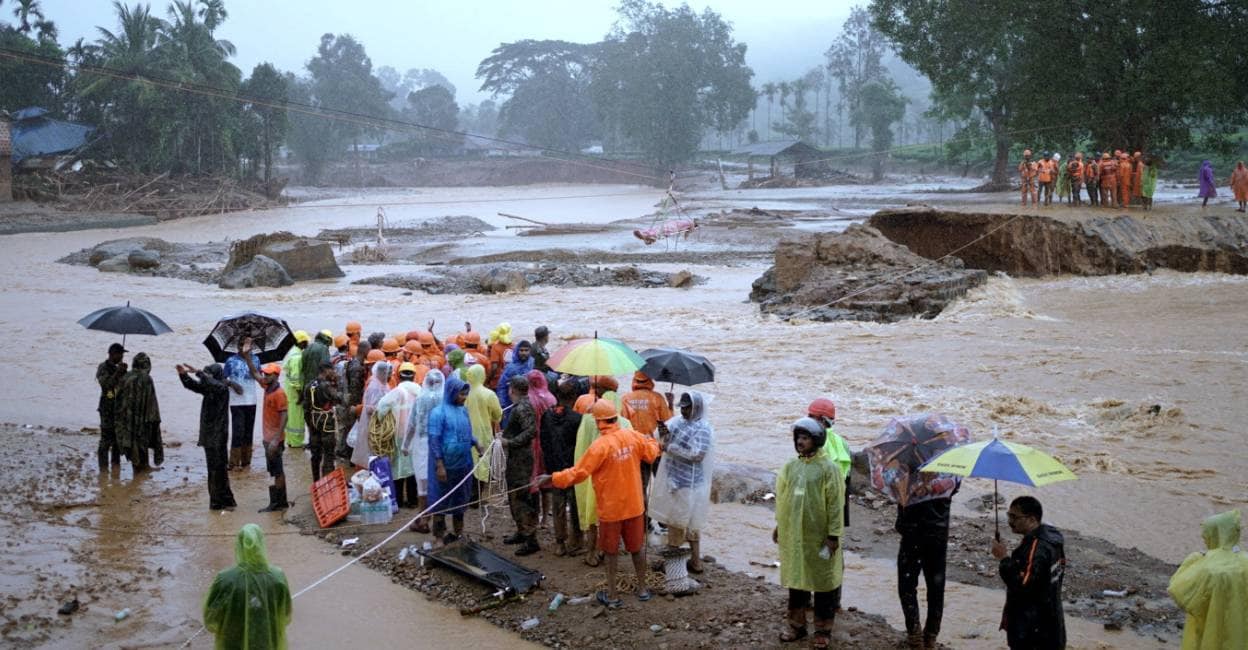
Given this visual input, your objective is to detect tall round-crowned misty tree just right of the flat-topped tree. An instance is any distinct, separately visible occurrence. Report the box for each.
[592,0,754,166]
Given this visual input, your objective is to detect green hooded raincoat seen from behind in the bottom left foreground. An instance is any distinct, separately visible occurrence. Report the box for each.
[203,524,291,650]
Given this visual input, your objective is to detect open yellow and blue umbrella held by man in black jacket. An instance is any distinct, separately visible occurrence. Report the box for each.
[919,435,1078,539]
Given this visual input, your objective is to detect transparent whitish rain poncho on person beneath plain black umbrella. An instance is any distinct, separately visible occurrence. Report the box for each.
[650,390,715,531]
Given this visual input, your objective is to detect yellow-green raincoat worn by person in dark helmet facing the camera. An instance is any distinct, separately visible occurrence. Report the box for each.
[776,453,845,591]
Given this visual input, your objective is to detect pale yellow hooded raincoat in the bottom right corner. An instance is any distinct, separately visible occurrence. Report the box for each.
[1169,510,1248,650]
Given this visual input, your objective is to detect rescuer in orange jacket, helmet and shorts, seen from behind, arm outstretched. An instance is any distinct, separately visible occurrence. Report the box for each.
[537,399,659,609]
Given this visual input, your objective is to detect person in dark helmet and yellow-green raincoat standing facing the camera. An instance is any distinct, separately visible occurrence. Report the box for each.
[771,418,845,648]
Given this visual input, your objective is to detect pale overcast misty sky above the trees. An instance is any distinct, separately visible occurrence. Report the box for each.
[39,0,861,104]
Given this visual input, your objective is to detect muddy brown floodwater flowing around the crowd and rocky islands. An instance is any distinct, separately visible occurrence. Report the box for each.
[0,186,1248,646]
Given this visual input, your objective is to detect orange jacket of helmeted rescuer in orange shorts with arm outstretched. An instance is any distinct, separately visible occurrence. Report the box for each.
[550,422,659,521]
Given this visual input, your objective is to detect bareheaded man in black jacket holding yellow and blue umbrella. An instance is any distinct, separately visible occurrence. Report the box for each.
[992,497,1066,650]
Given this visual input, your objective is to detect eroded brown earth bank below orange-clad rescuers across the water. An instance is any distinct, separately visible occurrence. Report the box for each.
[867,206,1248,277]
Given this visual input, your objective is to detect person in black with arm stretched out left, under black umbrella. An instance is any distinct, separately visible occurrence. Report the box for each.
[177,363,237,510]
